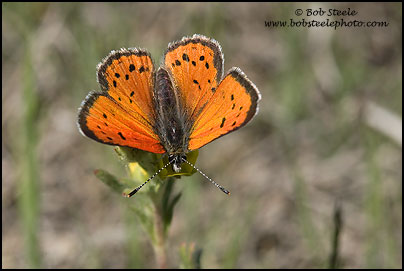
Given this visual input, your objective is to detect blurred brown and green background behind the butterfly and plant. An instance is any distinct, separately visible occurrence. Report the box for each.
[2,3,402,268]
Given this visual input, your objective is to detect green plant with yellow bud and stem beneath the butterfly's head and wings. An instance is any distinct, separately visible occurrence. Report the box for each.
[95,147,198,268]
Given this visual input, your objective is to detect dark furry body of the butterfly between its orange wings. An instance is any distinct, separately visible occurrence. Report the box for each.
[154,68,187,154]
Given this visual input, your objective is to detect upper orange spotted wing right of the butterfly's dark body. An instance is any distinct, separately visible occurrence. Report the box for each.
[164,35,223,121]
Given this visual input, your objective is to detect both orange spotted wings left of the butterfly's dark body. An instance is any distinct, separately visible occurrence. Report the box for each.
[78,48,165,153]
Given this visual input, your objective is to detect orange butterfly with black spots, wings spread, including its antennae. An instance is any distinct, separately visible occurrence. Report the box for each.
[77,34,261,196]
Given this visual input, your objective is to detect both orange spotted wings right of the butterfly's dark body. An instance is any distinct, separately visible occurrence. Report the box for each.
[164,35,260,150]
